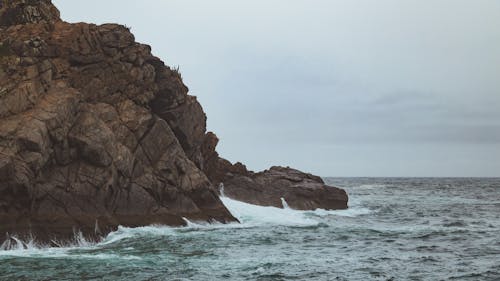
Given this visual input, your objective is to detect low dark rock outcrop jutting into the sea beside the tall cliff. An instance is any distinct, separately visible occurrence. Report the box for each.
[202,133,348,210]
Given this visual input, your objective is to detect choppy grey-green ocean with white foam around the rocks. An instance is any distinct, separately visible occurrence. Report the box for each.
[0,178,500,281]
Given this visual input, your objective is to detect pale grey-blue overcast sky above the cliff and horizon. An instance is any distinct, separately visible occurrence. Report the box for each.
[53,0,500,176]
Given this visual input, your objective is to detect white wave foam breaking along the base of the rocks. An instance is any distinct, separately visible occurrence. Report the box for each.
[0,192,371,254]
